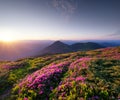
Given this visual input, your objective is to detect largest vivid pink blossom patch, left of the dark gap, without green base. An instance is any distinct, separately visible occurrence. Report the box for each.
[19,62,70,95]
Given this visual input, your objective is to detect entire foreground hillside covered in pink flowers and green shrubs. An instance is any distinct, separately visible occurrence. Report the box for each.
[0,44,120,100]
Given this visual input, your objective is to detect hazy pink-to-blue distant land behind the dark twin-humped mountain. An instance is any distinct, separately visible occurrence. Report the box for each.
[0,40,120,61]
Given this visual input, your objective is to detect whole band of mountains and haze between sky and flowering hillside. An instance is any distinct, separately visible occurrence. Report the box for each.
[0,40,120,61]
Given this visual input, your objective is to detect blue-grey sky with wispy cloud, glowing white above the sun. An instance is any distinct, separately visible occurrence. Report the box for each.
[0,0,120,40]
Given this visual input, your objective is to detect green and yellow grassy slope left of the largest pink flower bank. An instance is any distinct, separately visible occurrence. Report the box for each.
[0,54,69,99]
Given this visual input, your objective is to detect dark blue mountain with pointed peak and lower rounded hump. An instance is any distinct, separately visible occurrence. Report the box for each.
[41,41,104,55]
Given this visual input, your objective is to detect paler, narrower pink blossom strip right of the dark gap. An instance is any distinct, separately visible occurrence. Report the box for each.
[53,57,91,98]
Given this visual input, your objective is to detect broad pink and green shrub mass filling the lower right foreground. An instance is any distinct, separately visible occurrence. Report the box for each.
[50,57,120,100]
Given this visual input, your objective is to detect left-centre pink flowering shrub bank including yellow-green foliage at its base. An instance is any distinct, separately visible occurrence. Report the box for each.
[13,62,69,100]
